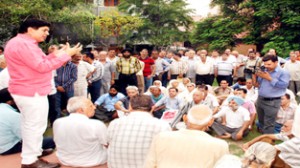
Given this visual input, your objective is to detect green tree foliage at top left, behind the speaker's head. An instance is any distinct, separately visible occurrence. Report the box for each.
[0,0,95,43]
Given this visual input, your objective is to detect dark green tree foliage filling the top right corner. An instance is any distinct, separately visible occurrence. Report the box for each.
[192,0,300,56]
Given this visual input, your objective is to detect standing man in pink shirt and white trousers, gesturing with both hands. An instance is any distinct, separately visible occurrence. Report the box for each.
[4,19,82,168]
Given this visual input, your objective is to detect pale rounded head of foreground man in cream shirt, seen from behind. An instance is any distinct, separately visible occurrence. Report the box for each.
[187,104,212,126]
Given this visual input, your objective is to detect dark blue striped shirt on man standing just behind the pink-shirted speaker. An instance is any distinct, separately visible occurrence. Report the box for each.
[54,61,77,92]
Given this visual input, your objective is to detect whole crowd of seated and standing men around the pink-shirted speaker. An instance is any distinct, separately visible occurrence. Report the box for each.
[0,45,300,168]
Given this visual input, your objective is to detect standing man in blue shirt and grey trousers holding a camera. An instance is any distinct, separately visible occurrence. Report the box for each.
[253,54,290,134]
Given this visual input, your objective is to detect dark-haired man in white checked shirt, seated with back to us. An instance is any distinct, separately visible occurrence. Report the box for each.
[108,95,171,168]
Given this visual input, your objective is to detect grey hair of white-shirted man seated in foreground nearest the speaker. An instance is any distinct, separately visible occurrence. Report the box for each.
[67,96,87,113]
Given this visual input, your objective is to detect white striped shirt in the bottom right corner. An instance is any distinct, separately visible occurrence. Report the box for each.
[275,137,300,168]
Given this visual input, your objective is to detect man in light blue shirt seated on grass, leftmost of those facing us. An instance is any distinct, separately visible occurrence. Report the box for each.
[94,85,125,122]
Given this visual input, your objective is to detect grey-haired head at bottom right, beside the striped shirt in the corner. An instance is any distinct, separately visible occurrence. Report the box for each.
[243,142,277,167]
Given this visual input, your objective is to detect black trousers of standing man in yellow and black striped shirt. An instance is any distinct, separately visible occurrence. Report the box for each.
[119,73,137,95]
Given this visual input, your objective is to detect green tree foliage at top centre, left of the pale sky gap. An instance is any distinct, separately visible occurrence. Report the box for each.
[119,0,193,46]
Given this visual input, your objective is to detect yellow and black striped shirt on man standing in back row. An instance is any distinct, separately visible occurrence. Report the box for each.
[116,56,141,75]
